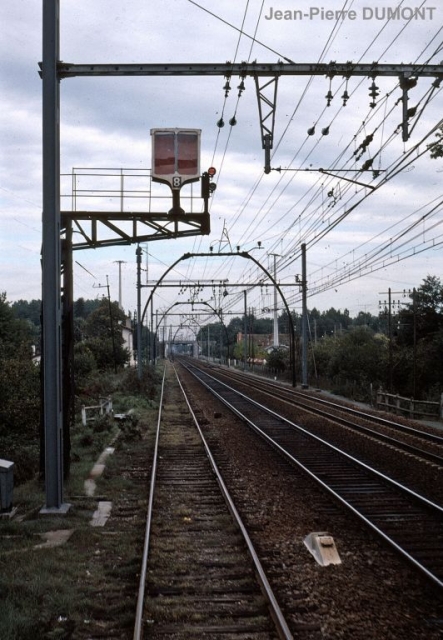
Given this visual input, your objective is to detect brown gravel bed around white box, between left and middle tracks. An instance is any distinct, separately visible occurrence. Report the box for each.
[181,370,443,640]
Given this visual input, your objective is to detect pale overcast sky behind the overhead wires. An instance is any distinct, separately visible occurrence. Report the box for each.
[0,0,443,336]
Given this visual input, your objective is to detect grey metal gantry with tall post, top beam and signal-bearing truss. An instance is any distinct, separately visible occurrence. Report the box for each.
[39,0,443,513]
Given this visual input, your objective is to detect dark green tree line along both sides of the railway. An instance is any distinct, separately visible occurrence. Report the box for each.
[0,276,443,477]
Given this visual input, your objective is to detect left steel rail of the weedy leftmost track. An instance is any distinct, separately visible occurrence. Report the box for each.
[133,367,166,640]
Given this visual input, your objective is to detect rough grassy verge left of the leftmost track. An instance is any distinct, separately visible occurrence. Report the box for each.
[0,364,157,640]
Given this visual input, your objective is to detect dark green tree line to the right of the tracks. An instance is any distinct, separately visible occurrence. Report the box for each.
[197,276,443,399]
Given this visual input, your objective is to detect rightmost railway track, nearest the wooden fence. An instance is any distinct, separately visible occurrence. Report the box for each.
[198,360,443,467]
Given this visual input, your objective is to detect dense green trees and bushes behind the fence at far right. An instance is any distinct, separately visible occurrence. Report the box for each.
[311,275,443,400]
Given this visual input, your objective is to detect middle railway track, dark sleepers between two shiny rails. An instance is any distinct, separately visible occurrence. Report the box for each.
[181,365,443,590]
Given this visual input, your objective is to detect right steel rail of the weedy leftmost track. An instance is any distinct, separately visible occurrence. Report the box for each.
[173,365,293,640]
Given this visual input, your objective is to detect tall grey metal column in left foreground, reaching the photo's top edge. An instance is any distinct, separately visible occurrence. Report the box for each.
[42,0,68,513]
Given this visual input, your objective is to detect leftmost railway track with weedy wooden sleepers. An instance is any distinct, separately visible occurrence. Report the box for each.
[133,367,292,640]
